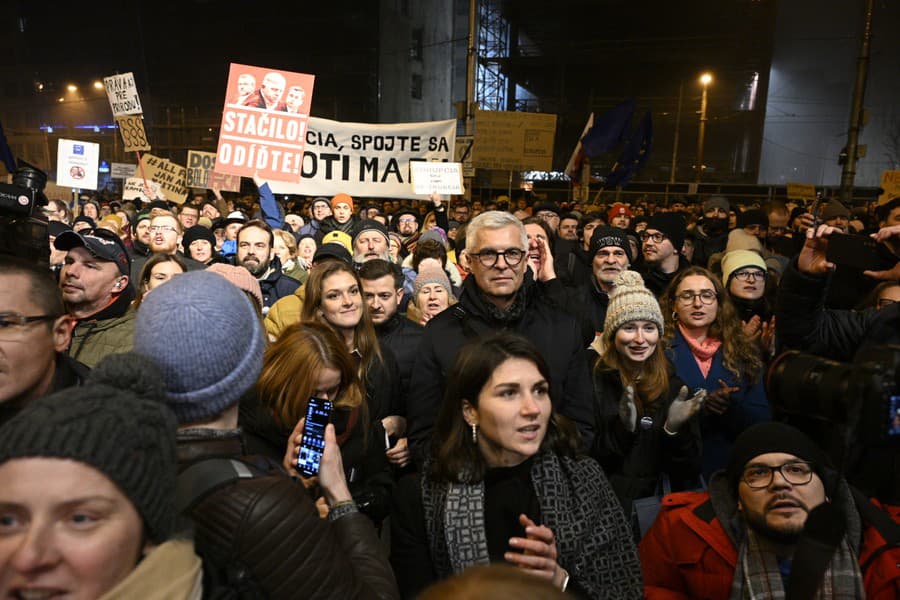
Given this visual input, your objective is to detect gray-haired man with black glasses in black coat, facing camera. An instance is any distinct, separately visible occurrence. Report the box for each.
[407,211,594,461]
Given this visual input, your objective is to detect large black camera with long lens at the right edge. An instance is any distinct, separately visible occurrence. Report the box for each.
[766,345,900,500]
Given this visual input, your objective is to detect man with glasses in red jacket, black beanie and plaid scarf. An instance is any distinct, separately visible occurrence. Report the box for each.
[640,423,900,598]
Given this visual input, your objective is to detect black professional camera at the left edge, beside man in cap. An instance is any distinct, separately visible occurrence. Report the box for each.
[0,161,50,266]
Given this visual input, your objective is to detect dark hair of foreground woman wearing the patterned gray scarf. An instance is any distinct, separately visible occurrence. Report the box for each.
[429,331,580,483]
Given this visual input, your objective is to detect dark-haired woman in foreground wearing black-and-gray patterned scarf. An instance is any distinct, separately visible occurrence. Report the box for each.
[391,332,642,599]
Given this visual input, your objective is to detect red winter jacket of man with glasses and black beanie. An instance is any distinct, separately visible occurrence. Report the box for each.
[639,492,900,600]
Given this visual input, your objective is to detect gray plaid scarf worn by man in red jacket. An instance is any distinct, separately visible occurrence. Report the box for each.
[730,528,866,600]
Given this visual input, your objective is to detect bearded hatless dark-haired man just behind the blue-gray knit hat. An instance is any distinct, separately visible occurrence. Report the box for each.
[235,219,300,314]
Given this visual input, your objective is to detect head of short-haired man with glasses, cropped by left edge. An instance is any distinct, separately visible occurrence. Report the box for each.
[0,257,88,424]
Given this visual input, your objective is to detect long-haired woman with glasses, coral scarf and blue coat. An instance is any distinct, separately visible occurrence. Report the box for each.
[660,267,771,478]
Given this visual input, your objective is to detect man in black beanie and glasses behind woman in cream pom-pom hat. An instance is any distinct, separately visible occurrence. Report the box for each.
[637,213,690,298]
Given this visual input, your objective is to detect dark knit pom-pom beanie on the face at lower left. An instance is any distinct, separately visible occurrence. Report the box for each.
[0,354,177,544]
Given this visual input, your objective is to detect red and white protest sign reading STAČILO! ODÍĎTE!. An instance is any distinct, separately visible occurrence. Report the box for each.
[216,63,315,183]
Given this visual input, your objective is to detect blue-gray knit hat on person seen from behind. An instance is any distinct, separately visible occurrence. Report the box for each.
[134,271,266,424]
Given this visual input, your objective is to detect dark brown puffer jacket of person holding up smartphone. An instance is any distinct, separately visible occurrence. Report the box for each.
[178,429,399,600]
